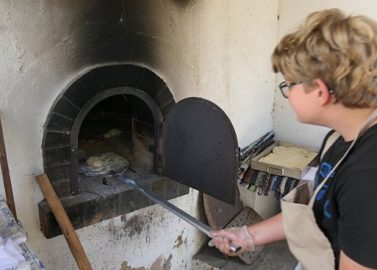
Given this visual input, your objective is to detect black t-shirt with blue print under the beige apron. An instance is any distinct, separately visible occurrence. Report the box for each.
[313,125,377,268]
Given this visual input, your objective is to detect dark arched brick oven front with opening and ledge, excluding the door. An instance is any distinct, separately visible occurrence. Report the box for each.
[38,65,189,238]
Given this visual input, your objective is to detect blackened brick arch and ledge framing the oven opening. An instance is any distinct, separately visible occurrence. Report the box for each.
[38,64,189,238]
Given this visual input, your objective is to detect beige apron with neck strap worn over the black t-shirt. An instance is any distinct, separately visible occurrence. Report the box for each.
[281,110,377,270]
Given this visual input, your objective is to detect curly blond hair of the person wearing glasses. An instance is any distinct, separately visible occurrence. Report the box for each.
[272,9,377,108]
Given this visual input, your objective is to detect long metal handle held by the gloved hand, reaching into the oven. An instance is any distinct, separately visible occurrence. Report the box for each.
[118,175,241,252]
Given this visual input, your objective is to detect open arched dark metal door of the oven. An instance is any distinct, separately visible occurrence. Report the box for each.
[163,97,239,204]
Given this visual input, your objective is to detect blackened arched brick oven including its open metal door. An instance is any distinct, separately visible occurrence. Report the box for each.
[39,64,238,238]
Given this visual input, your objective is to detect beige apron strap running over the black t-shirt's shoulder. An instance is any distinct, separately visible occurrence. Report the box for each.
[308,109,377,208]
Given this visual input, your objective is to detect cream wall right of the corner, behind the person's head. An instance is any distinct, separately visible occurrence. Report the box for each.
[273,0,377,149]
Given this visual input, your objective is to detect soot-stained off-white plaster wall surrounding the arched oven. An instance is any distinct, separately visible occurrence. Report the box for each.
[0,0,276,270]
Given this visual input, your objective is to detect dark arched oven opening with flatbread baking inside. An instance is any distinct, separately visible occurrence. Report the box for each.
[70,87,163,194]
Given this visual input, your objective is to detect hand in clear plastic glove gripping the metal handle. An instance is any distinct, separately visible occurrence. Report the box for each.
[208,225,255,256]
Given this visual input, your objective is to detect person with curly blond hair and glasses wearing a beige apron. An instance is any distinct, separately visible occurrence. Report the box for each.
[211,9,377,270]
